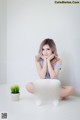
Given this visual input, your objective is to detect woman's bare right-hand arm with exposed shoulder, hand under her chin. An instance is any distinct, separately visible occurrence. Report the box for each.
[47,55,62,79]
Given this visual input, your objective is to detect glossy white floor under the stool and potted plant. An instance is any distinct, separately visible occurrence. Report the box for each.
[0,84,80,120]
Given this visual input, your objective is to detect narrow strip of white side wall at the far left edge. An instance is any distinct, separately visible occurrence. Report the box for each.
[0,0,6,84]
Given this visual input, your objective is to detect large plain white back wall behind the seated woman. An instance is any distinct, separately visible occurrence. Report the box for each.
[7,0,80,93]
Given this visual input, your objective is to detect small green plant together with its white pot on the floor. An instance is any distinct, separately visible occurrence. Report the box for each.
[11,85,20,101]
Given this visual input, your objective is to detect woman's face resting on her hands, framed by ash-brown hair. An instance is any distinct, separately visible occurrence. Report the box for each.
[42,44,52,59]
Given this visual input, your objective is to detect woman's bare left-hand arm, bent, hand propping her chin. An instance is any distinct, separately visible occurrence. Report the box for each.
[35,55,47,79]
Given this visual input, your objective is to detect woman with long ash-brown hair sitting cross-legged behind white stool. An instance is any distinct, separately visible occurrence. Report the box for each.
[26,39,74,99]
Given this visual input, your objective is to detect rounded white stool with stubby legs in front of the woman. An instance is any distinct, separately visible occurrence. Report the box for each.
[34,79,61,106]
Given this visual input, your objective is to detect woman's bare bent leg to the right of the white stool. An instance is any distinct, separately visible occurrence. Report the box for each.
[61,86,74,100]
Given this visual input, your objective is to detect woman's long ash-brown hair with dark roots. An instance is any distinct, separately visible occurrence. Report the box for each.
[39,38,59,62]
